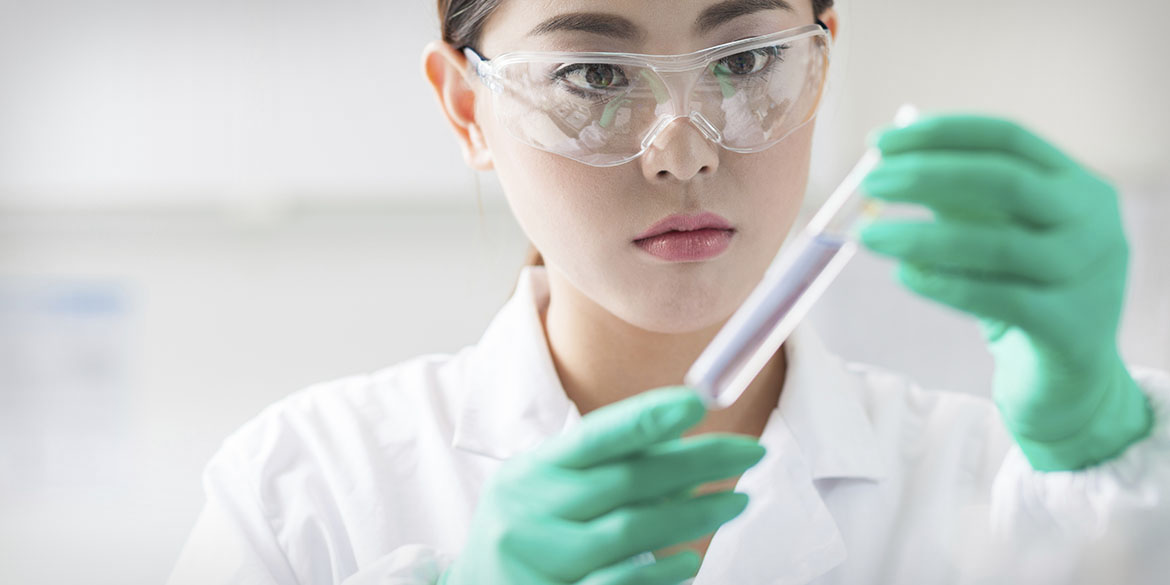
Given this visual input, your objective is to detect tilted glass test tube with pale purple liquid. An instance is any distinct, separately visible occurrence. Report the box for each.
[683,104,918,410]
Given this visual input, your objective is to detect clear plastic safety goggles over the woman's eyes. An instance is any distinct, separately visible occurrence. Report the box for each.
[463,21,830,166]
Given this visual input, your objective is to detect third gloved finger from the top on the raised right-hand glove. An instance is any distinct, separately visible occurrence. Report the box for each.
[860,220,1112,284]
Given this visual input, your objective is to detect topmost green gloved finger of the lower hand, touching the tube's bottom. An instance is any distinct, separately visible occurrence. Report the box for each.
[532,386,707,469]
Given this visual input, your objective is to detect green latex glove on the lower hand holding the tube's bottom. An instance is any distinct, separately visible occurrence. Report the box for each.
[439,386,764,585]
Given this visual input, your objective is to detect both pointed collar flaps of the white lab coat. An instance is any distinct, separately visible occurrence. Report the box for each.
[453,267,883,480]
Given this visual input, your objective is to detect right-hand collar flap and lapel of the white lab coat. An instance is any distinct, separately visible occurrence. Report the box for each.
[694,325,886,585]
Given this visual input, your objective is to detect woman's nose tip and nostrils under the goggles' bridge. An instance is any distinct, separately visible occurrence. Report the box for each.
[641,117,720,181]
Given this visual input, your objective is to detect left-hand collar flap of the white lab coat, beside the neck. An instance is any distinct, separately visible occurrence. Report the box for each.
[452,267,579,459]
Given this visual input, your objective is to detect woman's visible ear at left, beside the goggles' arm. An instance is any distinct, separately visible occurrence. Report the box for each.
[422,41,493,171]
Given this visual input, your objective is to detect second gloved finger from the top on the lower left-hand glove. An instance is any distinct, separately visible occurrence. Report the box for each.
[544,434,765,521]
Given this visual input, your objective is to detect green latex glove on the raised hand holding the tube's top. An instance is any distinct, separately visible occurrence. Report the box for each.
[861,115,1152,470]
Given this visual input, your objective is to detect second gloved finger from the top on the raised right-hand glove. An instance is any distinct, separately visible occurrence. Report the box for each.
[861,151,1094,227]
